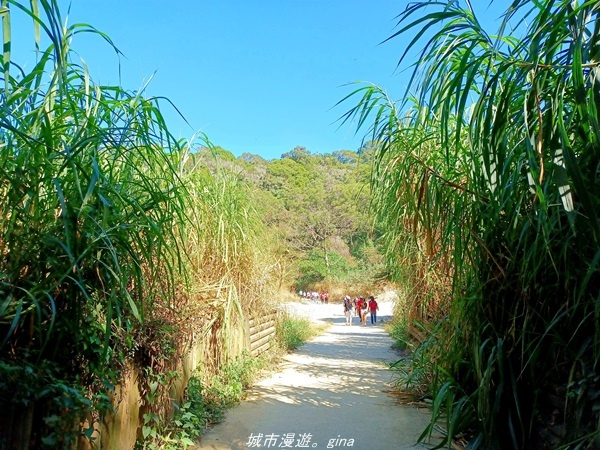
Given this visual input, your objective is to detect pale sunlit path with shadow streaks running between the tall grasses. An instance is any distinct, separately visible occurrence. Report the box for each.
[196,302,436,450]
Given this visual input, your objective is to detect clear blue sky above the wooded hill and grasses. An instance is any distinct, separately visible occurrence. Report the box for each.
[13,0,506,159]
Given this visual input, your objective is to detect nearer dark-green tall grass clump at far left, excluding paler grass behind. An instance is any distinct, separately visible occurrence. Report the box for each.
[0,1,192,438]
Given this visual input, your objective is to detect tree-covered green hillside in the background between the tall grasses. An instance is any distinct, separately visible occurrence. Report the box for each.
[195,145,385,295]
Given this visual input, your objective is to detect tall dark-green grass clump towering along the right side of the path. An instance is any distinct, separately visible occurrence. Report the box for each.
[345,0,600,448]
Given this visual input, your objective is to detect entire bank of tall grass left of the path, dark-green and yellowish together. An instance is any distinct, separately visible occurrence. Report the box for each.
[0,0,276,448]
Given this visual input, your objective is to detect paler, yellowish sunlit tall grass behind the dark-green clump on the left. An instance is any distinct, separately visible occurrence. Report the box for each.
[179,151,275,374]
